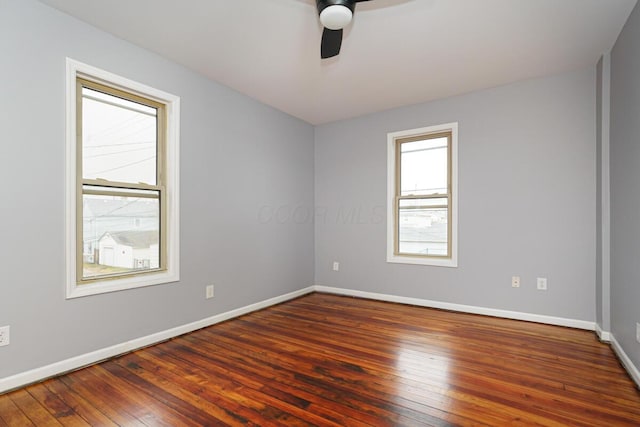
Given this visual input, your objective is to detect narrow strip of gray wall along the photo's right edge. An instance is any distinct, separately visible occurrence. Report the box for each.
[611,2,640,367]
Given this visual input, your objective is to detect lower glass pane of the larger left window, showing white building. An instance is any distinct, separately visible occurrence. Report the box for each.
[82,191,160,279]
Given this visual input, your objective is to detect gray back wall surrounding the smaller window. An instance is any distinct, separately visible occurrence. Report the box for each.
[315,67,596,321]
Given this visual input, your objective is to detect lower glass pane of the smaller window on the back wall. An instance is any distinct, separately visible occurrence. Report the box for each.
[398,199,448,256]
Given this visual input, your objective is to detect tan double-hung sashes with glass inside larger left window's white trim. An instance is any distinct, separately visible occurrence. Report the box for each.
[76,78,166,285]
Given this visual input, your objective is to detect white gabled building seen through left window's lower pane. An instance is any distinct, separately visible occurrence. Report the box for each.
[98,230,160,269]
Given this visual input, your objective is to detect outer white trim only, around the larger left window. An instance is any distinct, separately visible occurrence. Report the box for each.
[65,58,180,299]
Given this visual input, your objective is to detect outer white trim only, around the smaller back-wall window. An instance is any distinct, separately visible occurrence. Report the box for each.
[387,122,458,267]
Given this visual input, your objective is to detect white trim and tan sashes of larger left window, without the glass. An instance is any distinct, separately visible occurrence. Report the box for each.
[65,58,180,298]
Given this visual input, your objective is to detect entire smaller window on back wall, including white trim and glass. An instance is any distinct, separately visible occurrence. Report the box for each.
[387,123,457,267]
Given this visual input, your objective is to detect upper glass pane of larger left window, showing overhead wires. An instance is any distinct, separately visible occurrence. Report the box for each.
[82,87,157,185]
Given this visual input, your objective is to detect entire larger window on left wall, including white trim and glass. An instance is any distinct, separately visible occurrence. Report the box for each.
[67,60,179,297]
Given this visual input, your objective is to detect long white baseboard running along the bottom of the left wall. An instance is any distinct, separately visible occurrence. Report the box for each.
[0,286,314,393]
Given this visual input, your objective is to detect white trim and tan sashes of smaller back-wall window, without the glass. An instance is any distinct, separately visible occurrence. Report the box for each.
[387,122,458,267]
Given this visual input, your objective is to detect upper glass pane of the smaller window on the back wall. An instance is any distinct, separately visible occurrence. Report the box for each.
[400,137,448,196]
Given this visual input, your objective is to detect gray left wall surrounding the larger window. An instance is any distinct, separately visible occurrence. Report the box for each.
[0,0,314,378]
